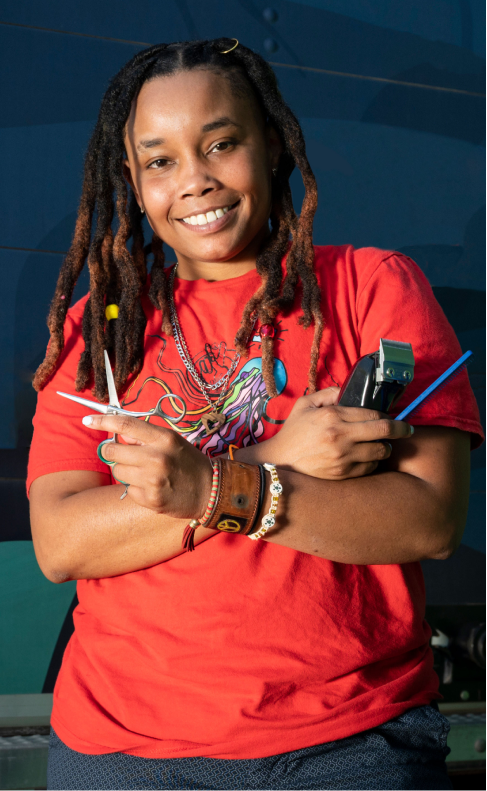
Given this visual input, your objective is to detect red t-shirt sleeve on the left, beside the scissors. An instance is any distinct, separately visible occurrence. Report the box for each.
[27,306,108,493]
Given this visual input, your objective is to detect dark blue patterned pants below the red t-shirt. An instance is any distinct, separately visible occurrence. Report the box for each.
[47,706,452,791]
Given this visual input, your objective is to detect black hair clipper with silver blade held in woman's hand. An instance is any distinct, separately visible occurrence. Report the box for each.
[338,338,414,412]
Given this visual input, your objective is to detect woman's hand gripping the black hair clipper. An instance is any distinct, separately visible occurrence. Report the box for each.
[266,387,414,481]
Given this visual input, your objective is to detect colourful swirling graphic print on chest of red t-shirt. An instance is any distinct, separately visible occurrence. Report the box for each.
[122,335,287,456]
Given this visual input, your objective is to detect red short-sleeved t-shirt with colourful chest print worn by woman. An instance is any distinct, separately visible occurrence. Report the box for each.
[28,246,482,759]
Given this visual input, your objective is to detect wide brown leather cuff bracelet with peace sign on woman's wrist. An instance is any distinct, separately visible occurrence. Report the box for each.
[205,457,262,535]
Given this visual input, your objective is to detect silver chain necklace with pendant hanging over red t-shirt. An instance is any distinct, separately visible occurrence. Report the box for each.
[169,263,255,436]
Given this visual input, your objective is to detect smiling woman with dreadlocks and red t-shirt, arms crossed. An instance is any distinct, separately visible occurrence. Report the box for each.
[28,39,481,791]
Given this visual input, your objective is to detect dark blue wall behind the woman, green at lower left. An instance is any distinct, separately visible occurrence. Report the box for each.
[0,0,485,694]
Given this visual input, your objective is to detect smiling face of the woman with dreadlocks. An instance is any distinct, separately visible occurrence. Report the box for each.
[125,70,281,276]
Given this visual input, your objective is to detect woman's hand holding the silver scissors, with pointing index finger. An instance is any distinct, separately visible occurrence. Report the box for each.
[83,415,213,519]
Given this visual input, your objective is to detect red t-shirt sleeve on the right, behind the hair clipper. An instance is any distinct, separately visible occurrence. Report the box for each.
[357,253,484,448]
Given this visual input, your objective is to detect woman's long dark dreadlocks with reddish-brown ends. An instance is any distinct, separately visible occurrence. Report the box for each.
[33,38,323,401]
